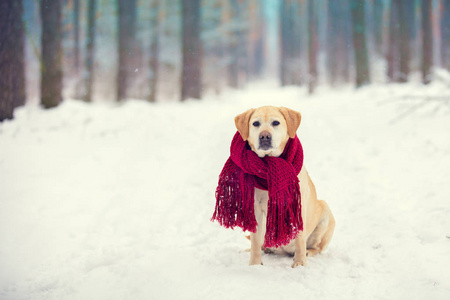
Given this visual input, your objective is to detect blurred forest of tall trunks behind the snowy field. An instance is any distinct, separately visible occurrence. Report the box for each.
[0,0,450,121]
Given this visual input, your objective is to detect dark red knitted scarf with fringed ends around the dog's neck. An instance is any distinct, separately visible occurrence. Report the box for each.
[211,132,303,247]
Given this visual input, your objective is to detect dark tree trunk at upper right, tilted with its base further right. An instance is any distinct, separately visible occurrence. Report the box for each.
[350,0,370,87]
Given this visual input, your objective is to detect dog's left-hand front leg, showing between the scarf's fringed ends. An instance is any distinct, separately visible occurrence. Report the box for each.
[249,189,269,266]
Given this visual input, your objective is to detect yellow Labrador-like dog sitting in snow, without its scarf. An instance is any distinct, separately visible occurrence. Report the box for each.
[235,106,336,268]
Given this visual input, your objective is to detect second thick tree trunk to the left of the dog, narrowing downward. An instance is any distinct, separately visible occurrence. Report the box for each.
[117,0,137,101]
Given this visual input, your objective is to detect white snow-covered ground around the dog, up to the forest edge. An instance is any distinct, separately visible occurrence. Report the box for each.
[0,83,450,300]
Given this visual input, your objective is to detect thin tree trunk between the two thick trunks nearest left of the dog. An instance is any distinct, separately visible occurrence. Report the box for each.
[148,0,160,102]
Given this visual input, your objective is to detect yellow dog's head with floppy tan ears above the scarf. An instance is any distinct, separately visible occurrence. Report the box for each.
[234,106,302,157]
